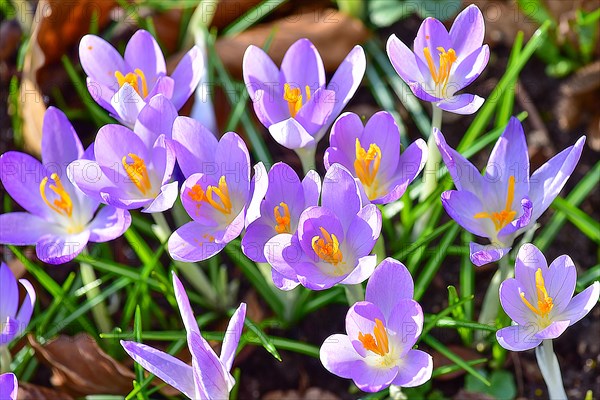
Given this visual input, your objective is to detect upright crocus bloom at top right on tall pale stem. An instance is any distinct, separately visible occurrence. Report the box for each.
[387,5,490,114]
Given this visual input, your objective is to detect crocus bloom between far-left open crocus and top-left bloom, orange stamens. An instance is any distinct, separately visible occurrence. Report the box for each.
[69,95,177,213]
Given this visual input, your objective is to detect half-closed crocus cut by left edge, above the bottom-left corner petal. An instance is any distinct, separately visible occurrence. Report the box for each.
[0,263,35,346]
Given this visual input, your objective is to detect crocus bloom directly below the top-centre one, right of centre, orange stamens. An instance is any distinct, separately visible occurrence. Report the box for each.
[324,111,427,204]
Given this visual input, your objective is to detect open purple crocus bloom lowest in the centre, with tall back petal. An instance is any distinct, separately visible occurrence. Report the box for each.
[320,258,433,392]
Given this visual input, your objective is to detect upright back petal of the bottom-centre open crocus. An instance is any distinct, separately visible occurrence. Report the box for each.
[365,257,414,320]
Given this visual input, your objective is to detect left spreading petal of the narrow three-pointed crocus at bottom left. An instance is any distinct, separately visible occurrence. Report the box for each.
[121,340,196,399]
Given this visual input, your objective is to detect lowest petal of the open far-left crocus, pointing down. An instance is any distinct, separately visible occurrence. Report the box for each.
[35,230,90,264]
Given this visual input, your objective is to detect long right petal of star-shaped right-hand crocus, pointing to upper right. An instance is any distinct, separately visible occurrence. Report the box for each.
[529,136,585,221]
